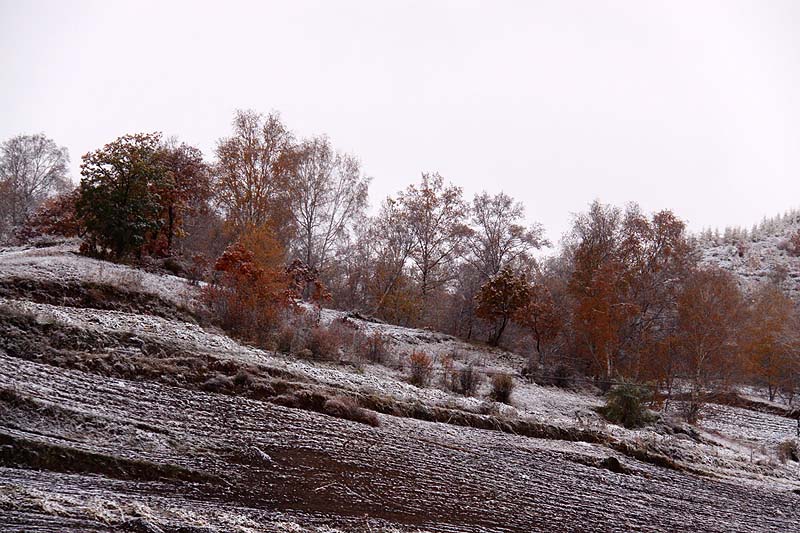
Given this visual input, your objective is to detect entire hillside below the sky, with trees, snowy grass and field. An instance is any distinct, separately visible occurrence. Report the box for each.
[0,120,800,533]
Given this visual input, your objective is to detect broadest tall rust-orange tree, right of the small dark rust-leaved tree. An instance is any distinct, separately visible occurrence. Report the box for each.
[567,202,693,378]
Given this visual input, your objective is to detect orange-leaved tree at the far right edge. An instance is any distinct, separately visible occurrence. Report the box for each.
[742,284,800,401]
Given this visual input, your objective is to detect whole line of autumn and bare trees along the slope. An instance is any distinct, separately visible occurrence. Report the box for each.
[6,111,800,417]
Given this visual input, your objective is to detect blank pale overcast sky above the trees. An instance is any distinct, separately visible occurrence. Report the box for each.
[0,0,800,241]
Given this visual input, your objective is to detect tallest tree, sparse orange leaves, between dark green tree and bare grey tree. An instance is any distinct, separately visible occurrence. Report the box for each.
[214,110,294,240]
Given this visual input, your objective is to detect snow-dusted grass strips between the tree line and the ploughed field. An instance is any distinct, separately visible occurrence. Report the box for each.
[0,243,800,487]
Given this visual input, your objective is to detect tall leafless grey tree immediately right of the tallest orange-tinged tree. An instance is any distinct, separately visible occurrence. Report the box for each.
[290,137,369,272]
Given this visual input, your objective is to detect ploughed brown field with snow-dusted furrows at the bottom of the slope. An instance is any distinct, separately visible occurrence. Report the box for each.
[0,357,800,532]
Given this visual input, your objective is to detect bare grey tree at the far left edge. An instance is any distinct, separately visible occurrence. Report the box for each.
[0,133,71,233]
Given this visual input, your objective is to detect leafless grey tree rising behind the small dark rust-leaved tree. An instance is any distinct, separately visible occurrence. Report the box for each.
[467,192,548,279]
